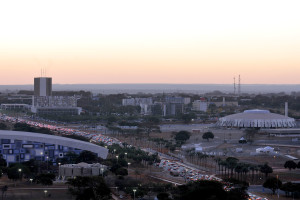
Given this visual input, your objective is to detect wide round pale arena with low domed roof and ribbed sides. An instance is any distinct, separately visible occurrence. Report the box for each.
[217,110,296,128]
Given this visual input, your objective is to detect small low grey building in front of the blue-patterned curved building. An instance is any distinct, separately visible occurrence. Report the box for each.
[58,162,107,180]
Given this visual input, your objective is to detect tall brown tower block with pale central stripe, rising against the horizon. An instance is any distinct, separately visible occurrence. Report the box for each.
[34,77,52,96]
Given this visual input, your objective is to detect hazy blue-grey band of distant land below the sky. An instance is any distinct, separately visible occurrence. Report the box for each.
[0,84,300,94]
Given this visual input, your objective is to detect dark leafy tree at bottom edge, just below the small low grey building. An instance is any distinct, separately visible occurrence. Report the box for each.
[67,176,111,200]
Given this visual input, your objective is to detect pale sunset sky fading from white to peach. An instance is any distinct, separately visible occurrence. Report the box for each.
[0,0,300,85]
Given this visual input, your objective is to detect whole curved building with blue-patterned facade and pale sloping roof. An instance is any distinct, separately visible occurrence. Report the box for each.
[0,130,108,164]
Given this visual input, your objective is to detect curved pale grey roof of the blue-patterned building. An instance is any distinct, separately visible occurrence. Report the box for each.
[0,130,108,159]
